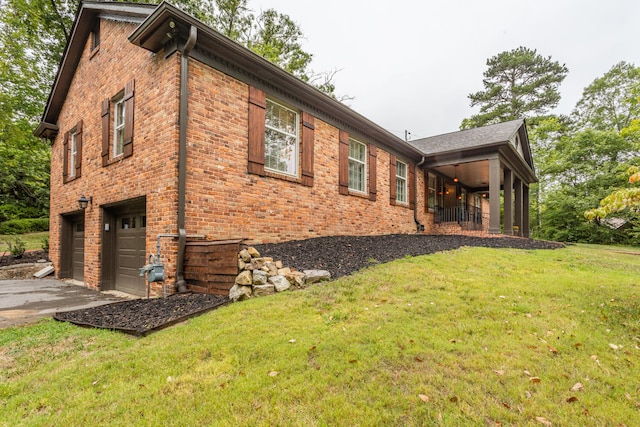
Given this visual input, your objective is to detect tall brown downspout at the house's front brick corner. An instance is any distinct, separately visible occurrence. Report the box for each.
[175,25,198,292]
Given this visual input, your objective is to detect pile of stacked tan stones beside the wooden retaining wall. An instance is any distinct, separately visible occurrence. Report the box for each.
[229,247,331,301]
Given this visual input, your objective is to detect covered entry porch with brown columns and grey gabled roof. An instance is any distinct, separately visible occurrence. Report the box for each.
[411,120,537,237]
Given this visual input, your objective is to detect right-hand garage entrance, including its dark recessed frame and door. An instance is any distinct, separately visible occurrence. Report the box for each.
[101,199,147,296]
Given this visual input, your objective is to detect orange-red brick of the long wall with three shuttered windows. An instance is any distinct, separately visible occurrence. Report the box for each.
[187,60,424,247]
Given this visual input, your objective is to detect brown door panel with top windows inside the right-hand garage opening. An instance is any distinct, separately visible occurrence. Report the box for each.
[114,212,147,296]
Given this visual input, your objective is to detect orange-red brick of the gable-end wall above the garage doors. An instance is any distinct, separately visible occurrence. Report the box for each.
[50,20,179,288]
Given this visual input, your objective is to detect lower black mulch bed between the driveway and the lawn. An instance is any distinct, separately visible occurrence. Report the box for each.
[53,293,229,335]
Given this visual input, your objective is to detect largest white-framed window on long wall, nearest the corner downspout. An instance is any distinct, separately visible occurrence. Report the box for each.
[264,99,299,177]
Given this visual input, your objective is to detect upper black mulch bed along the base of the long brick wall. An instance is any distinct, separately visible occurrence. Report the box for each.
[254,234,564,278]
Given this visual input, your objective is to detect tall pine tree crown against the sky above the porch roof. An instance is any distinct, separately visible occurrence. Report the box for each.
[460,47,569,129]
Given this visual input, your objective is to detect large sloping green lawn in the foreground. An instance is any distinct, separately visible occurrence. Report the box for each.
[0,245,640,426]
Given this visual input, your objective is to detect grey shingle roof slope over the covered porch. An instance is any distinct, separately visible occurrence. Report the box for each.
[409,119,524,155]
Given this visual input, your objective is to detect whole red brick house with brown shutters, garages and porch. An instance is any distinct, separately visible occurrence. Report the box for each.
[35,2,536,295]
